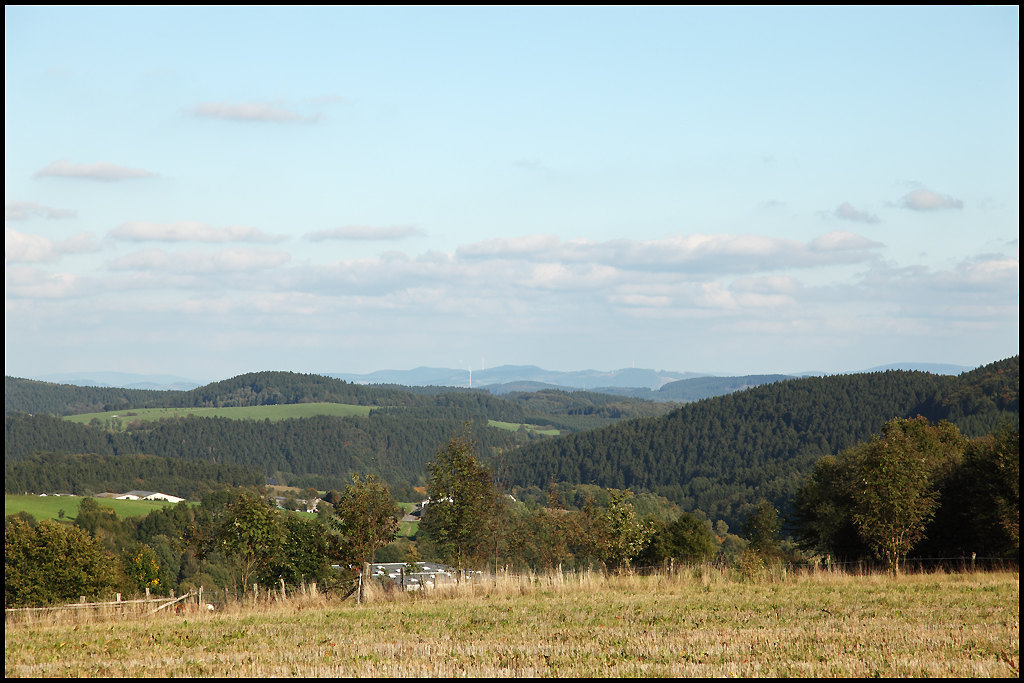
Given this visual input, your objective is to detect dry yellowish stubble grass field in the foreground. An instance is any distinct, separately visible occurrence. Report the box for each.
[4,567,1020,677]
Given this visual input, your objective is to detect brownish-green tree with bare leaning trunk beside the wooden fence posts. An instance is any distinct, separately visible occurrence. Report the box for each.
[331,474,401,564]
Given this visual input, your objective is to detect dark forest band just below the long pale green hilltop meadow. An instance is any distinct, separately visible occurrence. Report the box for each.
[4,413,514,493]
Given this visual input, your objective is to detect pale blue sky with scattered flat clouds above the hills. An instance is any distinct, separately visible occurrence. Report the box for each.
[4,6,1020,381]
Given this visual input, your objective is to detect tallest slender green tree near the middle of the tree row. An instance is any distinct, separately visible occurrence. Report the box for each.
[421,433,498,568]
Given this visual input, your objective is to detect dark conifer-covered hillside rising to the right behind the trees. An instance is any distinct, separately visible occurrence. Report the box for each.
[500,356,1020,524]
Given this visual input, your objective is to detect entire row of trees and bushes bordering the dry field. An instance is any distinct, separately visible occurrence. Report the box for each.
[5,417,1020,606]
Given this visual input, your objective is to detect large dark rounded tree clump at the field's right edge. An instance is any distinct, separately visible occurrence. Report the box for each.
[793,417,1020,571]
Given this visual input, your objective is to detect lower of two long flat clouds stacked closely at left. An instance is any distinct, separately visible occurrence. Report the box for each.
[108,248,292,275]
